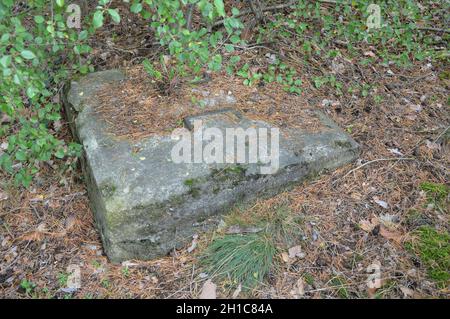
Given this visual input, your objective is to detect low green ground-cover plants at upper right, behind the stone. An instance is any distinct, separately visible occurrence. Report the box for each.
[256,0,442,97]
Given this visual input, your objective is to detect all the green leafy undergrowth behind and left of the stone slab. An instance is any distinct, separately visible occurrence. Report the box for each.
[0,0,448,187]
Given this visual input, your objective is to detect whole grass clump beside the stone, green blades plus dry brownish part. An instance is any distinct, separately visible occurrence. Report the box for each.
[201,206,302,290]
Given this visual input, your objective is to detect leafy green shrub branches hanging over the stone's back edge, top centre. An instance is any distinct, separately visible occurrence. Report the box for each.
[130,0,243,83]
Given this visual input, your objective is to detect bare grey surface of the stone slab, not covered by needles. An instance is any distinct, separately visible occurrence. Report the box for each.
[64,70,359,262]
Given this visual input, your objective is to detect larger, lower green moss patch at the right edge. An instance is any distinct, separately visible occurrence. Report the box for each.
[406,226,450,287]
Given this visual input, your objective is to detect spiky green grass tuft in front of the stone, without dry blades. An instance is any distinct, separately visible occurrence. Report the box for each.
[202,234,276,289]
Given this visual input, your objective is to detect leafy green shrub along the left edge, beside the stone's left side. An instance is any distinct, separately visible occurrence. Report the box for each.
[0,0,105,187]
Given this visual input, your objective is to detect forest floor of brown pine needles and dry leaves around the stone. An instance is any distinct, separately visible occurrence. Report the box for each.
[0,0,450,298]
